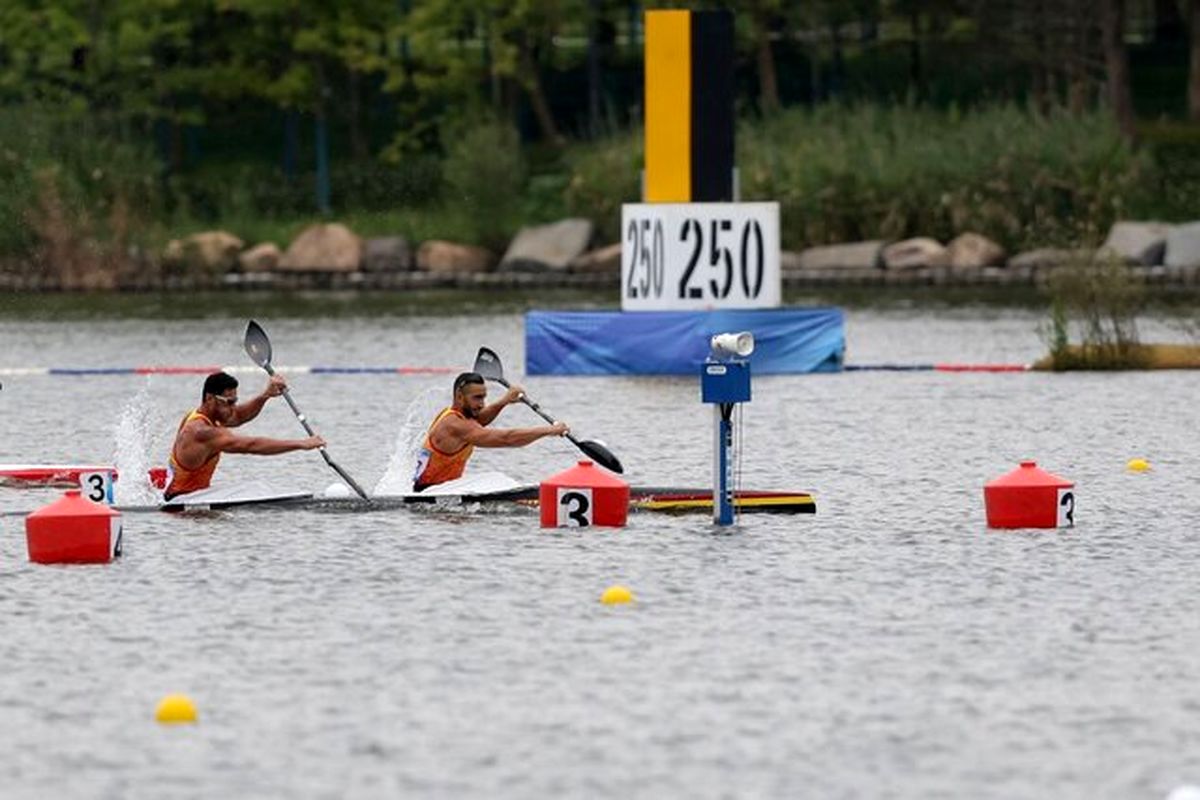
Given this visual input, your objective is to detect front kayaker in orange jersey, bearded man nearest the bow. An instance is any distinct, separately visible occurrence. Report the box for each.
[413,372,570,492]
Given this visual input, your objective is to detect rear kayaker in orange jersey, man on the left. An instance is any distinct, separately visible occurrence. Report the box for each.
[163,372,325,500]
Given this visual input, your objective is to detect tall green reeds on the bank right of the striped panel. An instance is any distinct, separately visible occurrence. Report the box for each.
[738,106,1152,248]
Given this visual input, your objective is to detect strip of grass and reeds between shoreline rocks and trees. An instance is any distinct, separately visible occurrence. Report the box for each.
[0,104,1200,278]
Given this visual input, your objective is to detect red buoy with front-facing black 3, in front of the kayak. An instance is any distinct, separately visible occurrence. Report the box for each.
[538,461,629,528]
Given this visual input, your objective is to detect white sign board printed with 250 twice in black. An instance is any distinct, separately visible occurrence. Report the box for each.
[620,203,781,311]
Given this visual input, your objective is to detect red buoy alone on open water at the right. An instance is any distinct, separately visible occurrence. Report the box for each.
[983,461,1075,528]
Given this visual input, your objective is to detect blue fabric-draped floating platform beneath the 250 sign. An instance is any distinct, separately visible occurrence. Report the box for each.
[526,308,846,375]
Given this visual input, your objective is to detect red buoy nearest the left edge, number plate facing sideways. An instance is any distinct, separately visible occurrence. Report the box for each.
[25,489,121,564]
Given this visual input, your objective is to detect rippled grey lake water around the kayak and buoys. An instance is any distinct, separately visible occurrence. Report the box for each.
[0,296,1200,799]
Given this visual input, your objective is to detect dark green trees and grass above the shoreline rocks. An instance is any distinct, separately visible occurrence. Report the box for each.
[0,0,1200,268]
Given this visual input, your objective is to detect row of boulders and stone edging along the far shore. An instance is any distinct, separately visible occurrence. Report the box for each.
[7,219,1200,291]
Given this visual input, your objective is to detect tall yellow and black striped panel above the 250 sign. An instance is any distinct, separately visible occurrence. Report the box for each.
[643,11,734,203]
